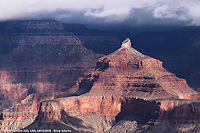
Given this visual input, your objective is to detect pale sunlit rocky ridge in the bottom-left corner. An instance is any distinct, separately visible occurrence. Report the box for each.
[0,92,70,131]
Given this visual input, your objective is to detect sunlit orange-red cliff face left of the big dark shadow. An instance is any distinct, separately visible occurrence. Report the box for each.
[38,96,121,121]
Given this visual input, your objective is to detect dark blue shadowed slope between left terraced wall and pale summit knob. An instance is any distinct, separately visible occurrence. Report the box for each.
[64,24,121,54]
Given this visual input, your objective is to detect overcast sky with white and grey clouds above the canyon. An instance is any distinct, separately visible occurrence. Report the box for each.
[0,0,200,26]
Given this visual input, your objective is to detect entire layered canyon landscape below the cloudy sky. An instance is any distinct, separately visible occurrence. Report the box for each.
[0,20,200,133]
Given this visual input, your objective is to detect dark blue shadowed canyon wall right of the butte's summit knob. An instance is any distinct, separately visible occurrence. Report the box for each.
[133,27,200,89]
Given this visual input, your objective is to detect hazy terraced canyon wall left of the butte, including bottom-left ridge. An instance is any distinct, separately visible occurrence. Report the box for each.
[0,21,107,130]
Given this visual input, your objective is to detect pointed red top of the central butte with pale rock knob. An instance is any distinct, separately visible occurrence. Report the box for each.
[98,38,162,68]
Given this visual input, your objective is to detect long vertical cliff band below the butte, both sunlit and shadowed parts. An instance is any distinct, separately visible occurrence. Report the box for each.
[38,96,200,121]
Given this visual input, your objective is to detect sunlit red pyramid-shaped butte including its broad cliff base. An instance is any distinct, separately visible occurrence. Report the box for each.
[1,39,200,133]
